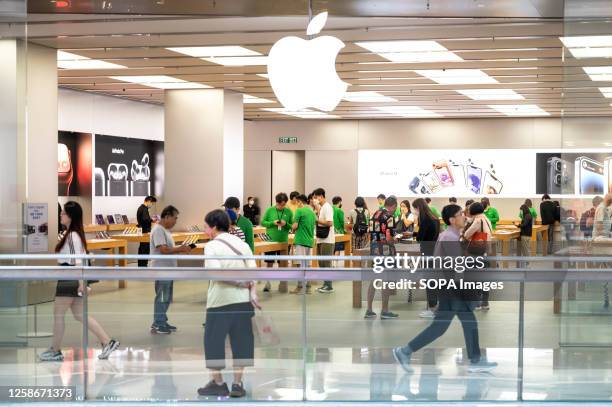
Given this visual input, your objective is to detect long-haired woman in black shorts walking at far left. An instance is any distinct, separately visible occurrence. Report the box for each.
[39,201,119,362]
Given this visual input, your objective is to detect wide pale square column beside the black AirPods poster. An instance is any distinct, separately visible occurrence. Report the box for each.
[163,89,244,229]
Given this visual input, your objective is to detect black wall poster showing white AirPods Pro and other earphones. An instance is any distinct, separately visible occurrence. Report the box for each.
[94,134,164,196]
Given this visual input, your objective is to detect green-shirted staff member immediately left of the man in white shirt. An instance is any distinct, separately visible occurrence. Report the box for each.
[289,194,317,294]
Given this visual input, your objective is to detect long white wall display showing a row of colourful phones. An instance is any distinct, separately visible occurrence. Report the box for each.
[358,149,536,198]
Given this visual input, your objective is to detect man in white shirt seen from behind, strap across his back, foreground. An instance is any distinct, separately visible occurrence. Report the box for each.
[198,209,261,397]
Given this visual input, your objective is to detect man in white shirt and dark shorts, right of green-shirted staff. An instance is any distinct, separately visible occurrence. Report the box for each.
[312,188,336,294]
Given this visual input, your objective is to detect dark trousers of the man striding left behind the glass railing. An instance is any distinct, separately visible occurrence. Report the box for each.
[404,298,480,362]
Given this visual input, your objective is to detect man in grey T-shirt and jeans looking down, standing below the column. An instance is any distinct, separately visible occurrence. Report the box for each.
[149,205,191,335]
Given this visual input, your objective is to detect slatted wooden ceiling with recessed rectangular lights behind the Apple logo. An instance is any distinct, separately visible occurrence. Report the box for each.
[9,0,612,120]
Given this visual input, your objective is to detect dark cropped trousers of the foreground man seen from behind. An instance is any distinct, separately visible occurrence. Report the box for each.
[204,302,255,370]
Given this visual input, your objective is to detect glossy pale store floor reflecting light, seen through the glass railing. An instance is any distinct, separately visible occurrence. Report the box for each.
[0,282,612,401]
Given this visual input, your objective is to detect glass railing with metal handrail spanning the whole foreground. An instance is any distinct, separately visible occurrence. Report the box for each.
[0,253,612,402]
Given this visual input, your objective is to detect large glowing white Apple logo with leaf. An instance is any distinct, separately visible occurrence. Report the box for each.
[268,12,349,112]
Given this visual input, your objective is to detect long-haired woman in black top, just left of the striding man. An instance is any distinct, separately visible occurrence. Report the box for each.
[412,198,440,318]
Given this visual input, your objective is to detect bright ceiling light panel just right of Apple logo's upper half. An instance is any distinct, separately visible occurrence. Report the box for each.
[355,40,463,63]
